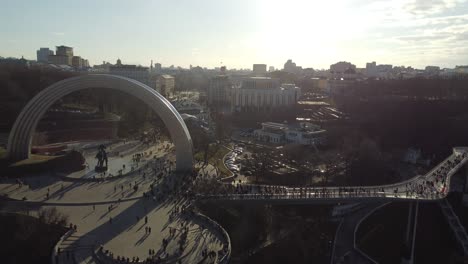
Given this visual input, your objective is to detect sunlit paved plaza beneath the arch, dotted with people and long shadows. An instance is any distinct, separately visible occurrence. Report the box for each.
[0,141,226,263]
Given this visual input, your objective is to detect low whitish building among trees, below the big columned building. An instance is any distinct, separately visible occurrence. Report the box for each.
[254,122,326,145]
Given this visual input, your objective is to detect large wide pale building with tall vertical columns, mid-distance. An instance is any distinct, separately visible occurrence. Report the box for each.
[228,77,301,112]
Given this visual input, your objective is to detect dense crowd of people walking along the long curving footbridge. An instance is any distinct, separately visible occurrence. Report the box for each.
[198,148,468,202]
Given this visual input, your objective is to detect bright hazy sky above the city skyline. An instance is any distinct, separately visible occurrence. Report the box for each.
[0,0,468,69]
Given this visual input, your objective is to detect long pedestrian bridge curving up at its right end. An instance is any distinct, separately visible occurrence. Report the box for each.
[197,147,468,203]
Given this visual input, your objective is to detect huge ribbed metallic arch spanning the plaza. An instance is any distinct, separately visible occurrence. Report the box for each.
[7,74,193,172]
